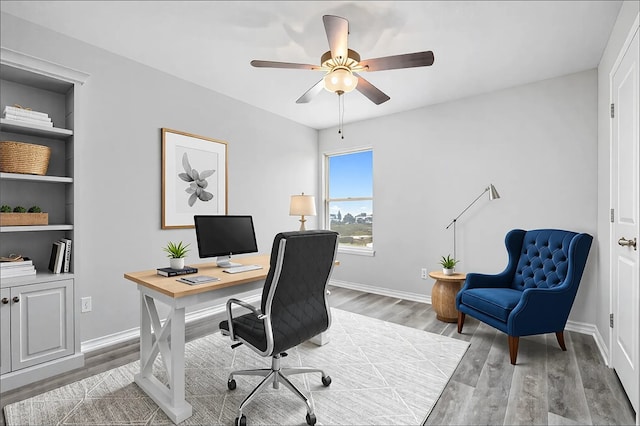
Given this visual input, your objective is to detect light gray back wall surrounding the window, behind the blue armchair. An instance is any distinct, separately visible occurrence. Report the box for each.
[319,70,598,323]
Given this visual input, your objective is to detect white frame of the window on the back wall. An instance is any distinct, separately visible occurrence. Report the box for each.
[322,146,375,256]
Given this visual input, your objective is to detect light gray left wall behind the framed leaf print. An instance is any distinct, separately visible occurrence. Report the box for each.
[1,14,318,342]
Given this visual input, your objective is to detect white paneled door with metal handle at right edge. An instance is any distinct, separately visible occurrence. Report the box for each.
[611,23,640,413]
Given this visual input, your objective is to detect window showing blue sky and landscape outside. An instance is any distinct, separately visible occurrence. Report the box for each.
[325,149,373,253]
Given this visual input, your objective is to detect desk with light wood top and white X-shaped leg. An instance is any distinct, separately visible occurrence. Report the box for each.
[124,255,269,424]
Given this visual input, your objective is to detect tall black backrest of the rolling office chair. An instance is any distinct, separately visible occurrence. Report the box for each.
[261,231,338,354]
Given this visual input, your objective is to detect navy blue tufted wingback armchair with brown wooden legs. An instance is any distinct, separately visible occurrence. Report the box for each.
[456,229,593,365]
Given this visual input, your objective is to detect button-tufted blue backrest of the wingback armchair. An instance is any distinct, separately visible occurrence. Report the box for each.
[506,229,591,290]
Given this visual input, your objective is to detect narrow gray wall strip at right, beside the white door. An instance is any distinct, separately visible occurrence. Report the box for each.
[593,1,640,349]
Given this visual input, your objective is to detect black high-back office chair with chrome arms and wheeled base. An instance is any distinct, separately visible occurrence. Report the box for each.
[220,231,338,426]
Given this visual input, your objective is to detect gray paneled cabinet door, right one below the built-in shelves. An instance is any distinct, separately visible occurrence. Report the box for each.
[10,280,74,371]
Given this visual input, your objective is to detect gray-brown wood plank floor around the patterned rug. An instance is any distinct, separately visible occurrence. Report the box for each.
[0,287,635,426]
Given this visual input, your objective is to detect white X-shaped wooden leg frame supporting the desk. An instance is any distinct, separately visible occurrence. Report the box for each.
[135,292,192,424]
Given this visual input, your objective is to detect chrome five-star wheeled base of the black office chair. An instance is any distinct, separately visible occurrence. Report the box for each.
[227,355,331,426]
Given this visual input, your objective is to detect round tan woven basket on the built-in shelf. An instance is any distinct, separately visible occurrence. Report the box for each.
[0,141,51,175]
